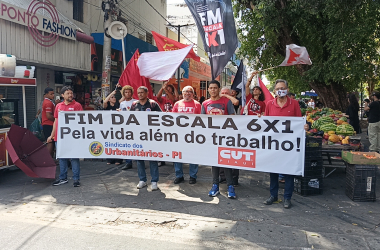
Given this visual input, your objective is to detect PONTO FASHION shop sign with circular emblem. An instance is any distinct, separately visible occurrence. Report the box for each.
[0,0,76,47]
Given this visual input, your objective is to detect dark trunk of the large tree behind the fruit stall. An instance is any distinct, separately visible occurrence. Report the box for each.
[309,82,348,112]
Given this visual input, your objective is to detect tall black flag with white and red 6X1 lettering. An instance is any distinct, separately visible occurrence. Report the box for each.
[185,0,238,79]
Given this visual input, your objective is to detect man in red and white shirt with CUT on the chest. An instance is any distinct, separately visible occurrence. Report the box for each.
[172,86,201,184]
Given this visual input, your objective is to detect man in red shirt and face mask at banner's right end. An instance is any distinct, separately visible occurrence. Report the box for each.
[259,79,308,208]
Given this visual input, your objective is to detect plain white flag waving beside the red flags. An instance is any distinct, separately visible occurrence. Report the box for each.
[137,45,193,81]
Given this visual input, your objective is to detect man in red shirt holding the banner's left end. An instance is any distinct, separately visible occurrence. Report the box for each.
[47,86,83,187]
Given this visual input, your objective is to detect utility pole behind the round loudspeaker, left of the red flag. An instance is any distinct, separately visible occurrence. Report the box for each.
[102,0,112,101]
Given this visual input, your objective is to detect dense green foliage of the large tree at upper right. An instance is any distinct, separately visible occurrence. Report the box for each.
[234,0,380,109]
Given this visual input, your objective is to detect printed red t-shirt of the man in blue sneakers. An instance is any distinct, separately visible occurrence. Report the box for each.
[201,97,235,115]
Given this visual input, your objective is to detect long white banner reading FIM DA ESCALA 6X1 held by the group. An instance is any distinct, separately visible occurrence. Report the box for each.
[57,111,305,175]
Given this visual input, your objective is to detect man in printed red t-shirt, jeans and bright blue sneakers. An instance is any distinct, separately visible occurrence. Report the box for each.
[201,80,236,199]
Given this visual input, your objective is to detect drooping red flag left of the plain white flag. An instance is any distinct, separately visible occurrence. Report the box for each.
[119,49,153,99]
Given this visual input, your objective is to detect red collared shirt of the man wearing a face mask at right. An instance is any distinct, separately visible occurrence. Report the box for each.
[265,97,302,117]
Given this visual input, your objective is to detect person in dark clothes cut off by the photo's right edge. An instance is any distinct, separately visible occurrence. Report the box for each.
[364,92,380,152]
